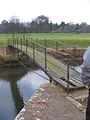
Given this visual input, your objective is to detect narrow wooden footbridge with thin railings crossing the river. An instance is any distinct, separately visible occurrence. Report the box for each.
[8,39,84,91]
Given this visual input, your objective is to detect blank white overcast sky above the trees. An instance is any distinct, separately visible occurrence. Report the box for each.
[0,0,90,24]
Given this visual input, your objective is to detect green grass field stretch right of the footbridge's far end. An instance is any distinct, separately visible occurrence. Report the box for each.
[31,33,90,47]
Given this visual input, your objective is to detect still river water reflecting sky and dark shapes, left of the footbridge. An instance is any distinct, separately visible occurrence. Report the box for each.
[0,66,49,120]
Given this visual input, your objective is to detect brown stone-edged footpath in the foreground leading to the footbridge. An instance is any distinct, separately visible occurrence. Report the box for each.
[15,84,87,120]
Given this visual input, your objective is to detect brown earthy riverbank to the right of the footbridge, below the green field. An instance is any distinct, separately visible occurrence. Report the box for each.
[47,48,85,66]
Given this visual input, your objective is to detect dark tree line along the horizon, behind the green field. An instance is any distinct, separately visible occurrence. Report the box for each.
[0,15,90,33]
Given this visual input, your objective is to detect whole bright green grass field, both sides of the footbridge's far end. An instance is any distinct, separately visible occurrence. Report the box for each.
[0,33,90,47]
